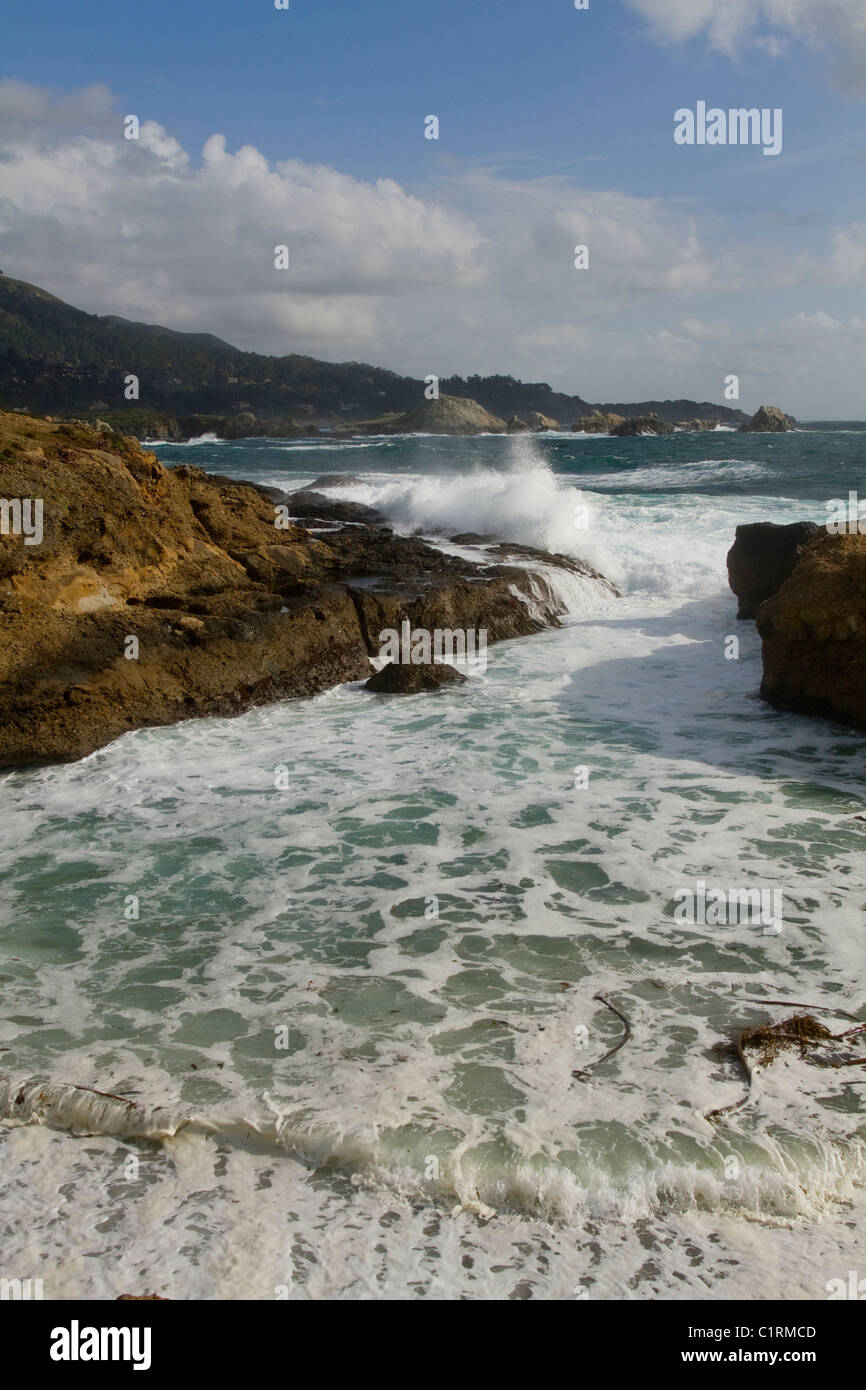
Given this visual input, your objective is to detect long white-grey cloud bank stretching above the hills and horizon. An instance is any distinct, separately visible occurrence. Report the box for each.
[0,82,866,414]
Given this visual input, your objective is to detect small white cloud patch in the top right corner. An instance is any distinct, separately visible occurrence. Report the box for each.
[626,0,866,97]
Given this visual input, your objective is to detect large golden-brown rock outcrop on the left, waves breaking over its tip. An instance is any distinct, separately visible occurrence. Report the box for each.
[0,414,617,766]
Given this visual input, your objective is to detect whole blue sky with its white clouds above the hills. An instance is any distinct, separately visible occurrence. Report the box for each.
[0,0,866,418]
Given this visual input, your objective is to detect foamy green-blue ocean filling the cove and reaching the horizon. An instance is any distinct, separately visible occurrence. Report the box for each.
[0,423,866,1301]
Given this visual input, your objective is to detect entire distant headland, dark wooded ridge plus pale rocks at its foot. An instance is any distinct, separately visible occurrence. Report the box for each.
[0,274,778,439]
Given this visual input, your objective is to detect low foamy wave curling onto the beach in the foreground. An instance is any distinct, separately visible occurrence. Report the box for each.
[0,1077,866,1222]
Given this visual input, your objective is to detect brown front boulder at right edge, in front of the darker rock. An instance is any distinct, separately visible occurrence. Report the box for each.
[758,531,866,728]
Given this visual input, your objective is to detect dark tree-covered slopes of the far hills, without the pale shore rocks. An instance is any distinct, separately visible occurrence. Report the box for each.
[0,274,746,434]
